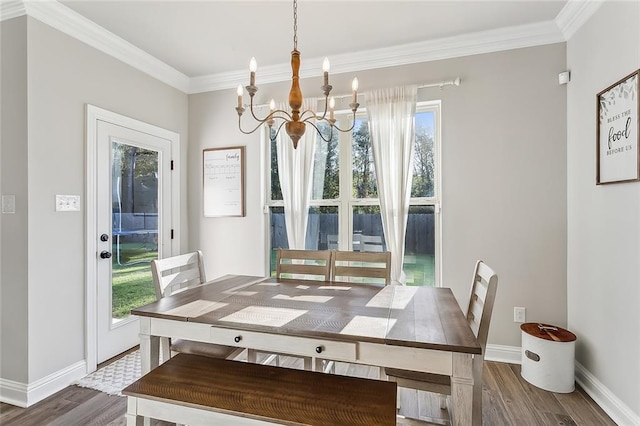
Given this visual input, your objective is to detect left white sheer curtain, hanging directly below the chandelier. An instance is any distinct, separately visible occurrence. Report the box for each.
[276,99,317,249]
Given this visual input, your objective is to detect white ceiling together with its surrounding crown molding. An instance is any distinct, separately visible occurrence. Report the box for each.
[2,0,589,93]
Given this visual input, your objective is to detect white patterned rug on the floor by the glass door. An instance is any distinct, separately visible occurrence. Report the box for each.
[76,350,142,396]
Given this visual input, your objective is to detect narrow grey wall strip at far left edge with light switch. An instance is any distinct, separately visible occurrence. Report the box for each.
[0,17,28,383]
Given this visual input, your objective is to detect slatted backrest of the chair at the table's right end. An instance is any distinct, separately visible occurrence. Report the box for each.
[467,260,498,354]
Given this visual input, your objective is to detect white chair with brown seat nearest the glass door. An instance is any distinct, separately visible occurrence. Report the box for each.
[151,250,243,361]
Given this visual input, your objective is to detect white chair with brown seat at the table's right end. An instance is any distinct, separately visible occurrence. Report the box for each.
[384,260,498,422]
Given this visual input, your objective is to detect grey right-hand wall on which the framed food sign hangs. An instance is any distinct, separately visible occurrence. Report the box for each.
[567,1,640,424]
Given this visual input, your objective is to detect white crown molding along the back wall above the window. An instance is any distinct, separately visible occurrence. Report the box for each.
[189,21,565,93]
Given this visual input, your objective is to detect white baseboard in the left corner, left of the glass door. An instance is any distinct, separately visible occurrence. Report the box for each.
[0,361,87,408]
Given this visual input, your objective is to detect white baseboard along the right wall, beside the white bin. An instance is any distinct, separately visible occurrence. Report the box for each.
[575,361,640,426]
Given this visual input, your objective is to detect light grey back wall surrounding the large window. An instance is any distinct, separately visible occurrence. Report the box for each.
[189,43,567,350]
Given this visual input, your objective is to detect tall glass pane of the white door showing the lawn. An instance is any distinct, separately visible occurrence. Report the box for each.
[111,142,158,322]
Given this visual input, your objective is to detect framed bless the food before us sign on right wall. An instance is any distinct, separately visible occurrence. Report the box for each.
[596,71,640,185]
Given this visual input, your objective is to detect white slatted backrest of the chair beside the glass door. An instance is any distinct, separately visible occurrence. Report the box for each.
[151,250,207,299]
